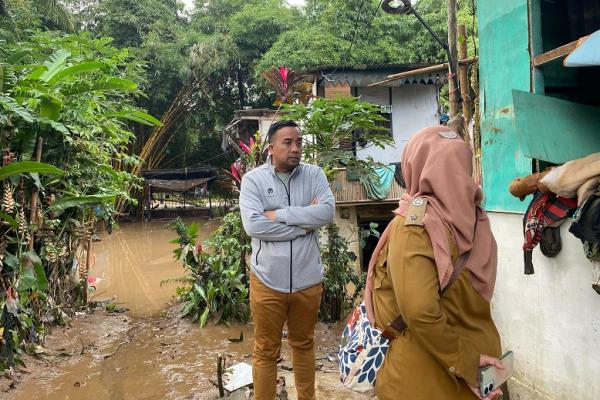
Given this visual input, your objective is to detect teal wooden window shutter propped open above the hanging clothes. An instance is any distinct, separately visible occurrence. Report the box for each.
[513,90,600,164]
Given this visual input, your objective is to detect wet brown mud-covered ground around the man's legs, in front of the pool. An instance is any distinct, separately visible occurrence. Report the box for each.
[0,307,363,400]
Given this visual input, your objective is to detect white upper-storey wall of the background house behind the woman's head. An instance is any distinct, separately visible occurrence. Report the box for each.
[356,84,439,163]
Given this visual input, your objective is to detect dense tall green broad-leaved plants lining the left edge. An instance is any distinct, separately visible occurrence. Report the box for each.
[0,31,158,368]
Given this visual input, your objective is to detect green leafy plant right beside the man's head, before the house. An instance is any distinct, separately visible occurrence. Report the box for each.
[282,97,393,188]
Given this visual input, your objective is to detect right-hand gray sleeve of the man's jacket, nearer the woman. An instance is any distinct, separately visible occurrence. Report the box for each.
[276,168,335,231]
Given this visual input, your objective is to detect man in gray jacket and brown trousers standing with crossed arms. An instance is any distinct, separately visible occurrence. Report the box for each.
[240,121,335,400]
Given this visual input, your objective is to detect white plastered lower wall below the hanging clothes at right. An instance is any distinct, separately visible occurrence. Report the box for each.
[490,213,600,400]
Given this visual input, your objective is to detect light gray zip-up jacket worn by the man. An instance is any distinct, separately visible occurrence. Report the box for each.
[240,158,335,292]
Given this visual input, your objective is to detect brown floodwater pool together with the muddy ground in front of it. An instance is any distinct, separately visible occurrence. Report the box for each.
[5,221,363,400]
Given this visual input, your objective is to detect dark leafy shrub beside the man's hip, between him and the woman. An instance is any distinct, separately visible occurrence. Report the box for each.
[319,223,366,322]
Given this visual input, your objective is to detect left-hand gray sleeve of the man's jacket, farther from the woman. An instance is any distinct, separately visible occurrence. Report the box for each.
[240,176,306,242]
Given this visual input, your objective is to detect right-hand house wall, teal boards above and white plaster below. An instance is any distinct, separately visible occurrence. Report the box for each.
[477,0,600,400]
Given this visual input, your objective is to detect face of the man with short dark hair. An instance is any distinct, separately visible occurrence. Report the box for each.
[269,126,302,172]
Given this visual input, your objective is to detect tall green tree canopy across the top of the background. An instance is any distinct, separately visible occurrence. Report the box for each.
[0,0,474,167]
